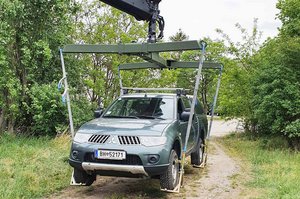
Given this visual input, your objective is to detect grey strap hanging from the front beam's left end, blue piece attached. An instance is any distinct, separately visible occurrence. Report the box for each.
[59,49,75,138]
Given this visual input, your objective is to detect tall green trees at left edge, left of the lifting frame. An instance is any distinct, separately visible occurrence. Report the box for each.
[0,0,76,132]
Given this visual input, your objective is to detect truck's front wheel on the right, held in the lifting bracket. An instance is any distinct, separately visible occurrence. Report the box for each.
[160,149,180,190]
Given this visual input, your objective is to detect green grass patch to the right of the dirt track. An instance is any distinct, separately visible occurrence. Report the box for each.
[218,134,300,199]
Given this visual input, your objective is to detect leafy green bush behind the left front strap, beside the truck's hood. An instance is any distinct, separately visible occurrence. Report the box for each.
[24,83,95,136]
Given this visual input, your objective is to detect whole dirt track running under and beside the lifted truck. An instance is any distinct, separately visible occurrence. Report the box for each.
[50,121,246,199]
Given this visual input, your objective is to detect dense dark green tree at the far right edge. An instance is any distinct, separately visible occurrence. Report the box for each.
[246,0,300,143]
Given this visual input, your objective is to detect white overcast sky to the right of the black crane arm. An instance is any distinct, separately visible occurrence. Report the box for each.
[160,0,281,41]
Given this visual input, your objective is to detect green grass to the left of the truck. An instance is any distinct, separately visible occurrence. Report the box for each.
[0,134,71,199]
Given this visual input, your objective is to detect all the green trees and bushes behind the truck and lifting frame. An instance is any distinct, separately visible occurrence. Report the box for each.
[0,0,300,146]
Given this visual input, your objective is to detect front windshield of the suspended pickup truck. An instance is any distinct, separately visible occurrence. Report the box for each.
[103,97,174,119]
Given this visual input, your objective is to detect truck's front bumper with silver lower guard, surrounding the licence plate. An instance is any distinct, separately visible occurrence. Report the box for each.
[69,143,170,177]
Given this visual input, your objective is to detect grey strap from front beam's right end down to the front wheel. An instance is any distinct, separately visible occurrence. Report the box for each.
[177,41,207,192]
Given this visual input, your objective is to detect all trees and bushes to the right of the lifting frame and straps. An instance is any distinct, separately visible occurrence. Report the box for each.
[218,6,300,147]
